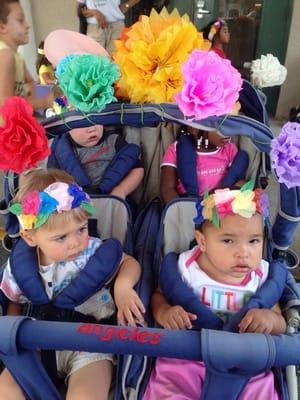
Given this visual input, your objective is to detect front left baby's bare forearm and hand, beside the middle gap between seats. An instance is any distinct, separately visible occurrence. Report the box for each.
[114,254,145,326]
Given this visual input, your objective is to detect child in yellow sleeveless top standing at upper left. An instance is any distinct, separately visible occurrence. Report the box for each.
[0,0,53,109]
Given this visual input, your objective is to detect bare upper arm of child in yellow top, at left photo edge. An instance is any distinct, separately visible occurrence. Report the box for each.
[0,49,16,105]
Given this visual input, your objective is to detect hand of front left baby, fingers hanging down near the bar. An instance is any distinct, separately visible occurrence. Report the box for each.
[115,288,145,326]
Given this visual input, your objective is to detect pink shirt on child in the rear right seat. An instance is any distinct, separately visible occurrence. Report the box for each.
[161,142,238,196]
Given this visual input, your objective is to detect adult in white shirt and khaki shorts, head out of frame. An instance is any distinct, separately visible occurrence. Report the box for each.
[77,0,140,54]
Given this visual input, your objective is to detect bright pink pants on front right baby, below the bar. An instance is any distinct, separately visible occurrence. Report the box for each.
[143,358,279,400]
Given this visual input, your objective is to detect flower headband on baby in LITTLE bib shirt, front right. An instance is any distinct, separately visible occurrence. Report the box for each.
[194,181,269,227]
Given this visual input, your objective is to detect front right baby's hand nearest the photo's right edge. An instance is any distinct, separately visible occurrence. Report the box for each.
[239,304,286,335]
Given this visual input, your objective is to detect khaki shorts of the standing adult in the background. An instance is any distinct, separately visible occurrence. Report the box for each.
[87,21,124,54]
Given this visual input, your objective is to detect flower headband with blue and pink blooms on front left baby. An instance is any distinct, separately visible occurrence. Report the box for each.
[9,182,95,229]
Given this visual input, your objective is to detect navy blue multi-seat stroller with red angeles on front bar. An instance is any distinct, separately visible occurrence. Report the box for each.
[0,81,300,400]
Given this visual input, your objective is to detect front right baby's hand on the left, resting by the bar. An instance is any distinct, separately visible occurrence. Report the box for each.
[151,289,197,329]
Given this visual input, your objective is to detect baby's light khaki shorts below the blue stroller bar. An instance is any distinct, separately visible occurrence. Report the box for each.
[56,350,116,380]
